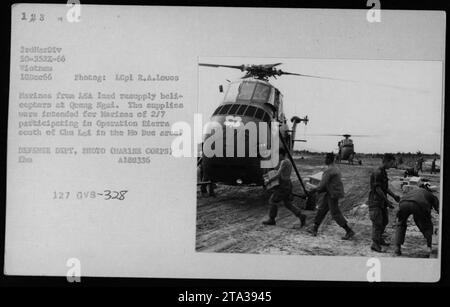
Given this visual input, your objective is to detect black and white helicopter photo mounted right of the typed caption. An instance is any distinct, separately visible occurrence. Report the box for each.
[196,57,443,258]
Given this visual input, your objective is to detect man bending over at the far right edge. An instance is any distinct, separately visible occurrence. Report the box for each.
[394,185,439,256]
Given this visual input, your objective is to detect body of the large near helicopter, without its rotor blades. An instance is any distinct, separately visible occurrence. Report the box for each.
[201,79,288,185]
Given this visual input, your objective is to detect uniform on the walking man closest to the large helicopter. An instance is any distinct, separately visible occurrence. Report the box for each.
[269,159,302,220]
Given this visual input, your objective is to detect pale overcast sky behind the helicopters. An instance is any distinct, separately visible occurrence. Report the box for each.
[198,57,442,153]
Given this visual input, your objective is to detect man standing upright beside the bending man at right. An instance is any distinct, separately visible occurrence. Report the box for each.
[368,153,400,253]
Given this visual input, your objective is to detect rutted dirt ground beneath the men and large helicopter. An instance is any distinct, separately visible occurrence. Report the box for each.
[196,156,440,258]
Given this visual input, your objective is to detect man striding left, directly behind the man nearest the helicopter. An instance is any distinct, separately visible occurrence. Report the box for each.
[309,152,355,240]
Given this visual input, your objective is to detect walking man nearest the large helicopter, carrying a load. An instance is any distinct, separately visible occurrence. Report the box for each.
[263,148,306,227]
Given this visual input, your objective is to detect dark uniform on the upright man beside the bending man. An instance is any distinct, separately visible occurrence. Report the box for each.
[368,166,389,244]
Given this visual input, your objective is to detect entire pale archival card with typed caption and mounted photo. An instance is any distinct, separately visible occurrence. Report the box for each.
[2,1,448,286]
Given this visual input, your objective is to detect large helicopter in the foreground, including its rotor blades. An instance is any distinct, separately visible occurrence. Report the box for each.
[198,63,340,199]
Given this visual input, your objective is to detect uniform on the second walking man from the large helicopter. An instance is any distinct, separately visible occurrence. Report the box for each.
[314,166,347,228]
